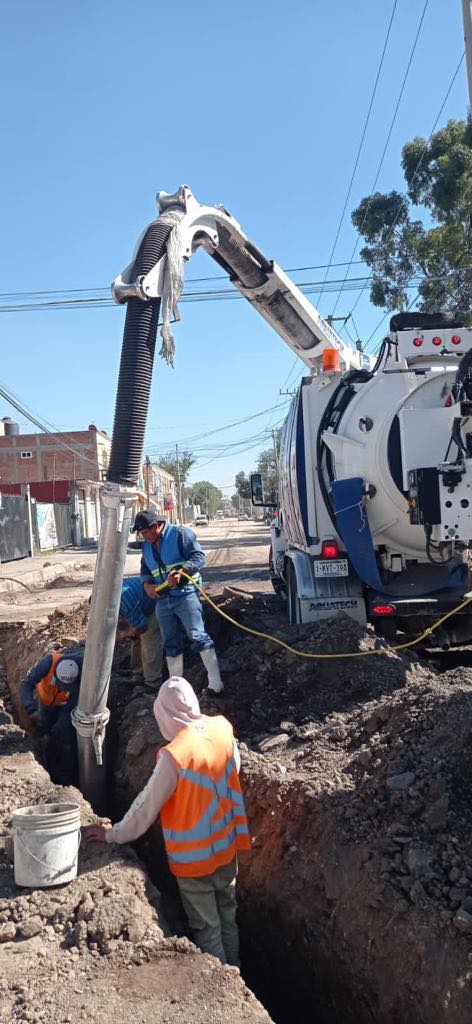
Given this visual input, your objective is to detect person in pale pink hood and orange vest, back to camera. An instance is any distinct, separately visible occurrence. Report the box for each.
[84,676,251,967]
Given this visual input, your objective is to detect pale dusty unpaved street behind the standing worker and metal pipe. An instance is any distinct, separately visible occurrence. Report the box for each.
[0,519,271,623]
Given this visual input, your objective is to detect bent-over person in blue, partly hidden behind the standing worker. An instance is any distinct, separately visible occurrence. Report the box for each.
[117,577,162,689]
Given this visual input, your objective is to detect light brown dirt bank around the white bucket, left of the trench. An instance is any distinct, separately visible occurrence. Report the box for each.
[0,610,270,1024]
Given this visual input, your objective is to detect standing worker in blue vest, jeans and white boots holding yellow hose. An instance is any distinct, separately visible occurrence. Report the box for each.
[133,509,223,693]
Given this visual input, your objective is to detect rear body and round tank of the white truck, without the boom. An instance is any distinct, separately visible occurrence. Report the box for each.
[271,313,472,634]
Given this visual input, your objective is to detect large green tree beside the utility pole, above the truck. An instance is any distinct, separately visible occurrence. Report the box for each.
[352,121,472,321]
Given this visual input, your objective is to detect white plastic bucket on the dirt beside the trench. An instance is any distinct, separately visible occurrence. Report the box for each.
[11,803,81,889]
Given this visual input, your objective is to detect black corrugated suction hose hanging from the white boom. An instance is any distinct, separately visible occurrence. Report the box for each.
[106,220,171,484]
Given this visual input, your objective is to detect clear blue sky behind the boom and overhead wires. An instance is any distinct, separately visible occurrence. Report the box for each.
[0,0,467,494]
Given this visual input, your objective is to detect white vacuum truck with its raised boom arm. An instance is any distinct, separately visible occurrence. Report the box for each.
[113,185,472,644]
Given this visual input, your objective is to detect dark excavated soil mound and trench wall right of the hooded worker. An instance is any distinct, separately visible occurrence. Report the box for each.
[5,596,472,1024]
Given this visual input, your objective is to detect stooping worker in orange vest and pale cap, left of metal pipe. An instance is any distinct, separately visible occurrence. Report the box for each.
[19,651,82,785]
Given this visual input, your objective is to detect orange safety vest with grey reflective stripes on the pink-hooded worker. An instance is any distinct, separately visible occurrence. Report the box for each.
[158,715,251,878]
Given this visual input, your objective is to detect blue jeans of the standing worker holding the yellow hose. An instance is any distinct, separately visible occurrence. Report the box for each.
[156,590,214,657]
